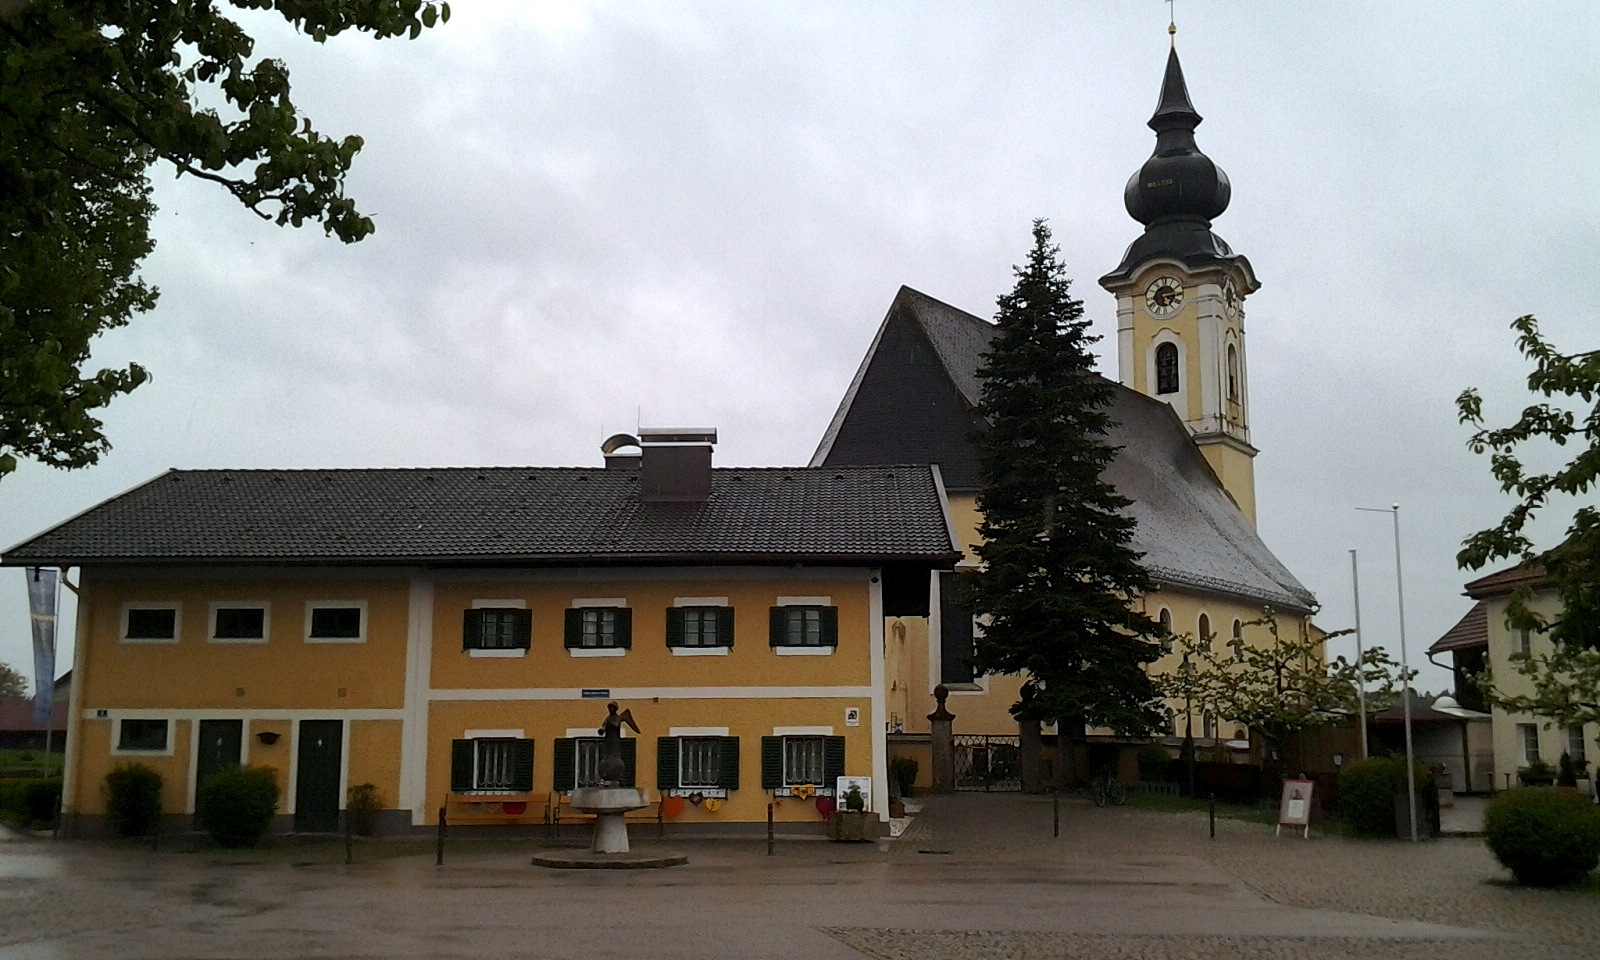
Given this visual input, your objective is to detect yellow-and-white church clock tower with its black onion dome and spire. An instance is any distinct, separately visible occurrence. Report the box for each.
[1101,45,1261,525]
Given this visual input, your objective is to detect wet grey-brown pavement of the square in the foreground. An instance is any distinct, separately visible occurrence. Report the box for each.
[0,795,1600,960]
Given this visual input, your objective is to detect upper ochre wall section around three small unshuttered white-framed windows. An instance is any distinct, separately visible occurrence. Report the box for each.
[75,578,406,710]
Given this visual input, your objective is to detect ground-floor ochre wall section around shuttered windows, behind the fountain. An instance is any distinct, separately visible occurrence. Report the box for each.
[427,696,882,824]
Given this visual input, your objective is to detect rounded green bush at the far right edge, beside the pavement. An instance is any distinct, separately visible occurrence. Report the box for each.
[1483,787,1600,886]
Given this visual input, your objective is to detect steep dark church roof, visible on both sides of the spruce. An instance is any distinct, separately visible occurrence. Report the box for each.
[811,286,1317,613]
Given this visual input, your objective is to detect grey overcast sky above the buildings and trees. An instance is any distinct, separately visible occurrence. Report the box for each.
[0,0,1600,700]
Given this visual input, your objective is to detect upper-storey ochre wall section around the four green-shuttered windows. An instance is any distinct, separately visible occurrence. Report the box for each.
[432,576,872,690]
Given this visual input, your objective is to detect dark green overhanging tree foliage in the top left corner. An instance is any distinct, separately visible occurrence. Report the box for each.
[0,0,450,477]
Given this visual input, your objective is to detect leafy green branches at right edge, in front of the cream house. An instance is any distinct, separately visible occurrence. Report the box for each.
[1456,315,1600,652]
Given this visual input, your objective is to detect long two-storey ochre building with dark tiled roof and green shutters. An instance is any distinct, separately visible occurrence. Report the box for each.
[5,430,957,832]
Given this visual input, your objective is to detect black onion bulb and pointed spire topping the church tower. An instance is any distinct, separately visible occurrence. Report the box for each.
[1123,48,1232,226]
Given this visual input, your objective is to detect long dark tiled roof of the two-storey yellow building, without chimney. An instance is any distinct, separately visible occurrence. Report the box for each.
[3,466,958,566]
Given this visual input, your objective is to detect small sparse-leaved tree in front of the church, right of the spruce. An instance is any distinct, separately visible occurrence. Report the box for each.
[1160,610,1414,755]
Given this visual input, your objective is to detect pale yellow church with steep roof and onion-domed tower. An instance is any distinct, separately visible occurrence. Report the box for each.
[811,50,1320,780]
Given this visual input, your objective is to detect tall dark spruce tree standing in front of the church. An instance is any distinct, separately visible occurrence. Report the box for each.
[971,219,1162,734]
